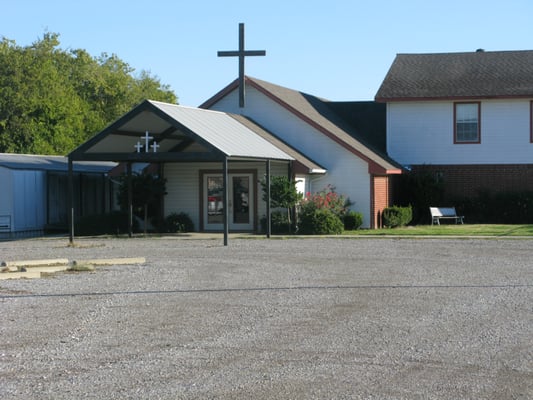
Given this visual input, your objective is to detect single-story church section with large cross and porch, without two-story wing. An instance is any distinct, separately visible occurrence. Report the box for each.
[69,24,402,238]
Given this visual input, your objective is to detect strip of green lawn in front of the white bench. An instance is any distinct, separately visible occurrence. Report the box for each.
[344,224,533,237]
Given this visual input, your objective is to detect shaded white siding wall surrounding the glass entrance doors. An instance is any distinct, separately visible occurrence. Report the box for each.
[164,161,288,230]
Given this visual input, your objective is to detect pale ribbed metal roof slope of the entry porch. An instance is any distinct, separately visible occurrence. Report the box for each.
[149,100,294,161]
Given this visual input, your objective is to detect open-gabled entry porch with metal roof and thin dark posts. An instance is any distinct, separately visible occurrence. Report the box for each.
[68,100,320,245]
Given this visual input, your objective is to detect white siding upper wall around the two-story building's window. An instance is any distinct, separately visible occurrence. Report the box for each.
[387,99,533,165]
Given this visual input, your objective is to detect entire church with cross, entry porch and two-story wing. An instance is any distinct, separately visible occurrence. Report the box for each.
[69,24,533,238]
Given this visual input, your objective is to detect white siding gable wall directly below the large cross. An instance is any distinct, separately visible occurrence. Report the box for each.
[208,87,371,227]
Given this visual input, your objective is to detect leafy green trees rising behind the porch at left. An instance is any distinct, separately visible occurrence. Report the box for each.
[0,33,177,154]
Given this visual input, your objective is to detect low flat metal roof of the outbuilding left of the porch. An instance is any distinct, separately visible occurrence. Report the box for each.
[0,153,117,173]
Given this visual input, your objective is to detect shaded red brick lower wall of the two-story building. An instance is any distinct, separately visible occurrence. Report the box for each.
[413,164,533,199]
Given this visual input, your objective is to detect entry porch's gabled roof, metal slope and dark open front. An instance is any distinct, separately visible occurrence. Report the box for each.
[69,100,294,162]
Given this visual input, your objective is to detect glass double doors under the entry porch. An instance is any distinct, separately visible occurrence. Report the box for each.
[202,173,255,231]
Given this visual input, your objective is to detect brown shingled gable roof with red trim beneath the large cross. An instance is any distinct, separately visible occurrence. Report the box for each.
[200,76,402,174]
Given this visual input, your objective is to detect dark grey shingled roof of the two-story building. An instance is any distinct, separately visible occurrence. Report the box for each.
[376,50,533,102]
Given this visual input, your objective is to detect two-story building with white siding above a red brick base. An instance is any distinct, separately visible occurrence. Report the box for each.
[376,50,533,198]
